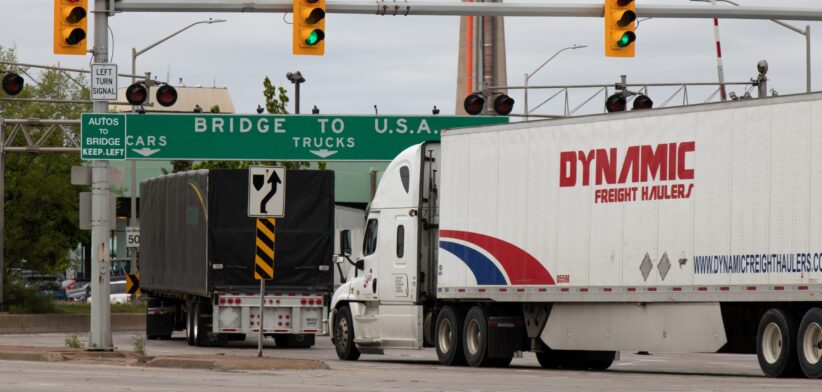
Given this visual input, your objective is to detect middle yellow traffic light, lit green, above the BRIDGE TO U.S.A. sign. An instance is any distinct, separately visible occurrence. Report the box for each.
[293,0,325,56]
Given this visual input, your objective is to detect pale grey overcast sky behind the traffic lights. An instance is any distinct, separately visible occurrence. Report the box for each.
[0,0,822,115]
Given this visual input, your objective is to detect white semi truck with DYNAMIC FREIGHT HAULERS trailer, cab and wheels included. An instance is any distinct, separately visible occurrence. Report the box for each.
[330,94,822,378]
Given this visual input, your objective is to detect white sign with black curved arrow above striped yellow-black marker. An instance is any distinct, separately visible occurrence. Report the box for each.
[248,166,285,218]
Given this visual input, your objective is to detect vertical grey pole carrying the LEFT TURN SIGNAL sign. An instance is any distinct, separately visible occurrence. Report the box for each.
[87,0,114,351]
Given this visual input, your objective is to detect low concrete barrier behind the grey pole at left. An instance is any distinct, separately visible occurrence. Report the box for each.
[0,313,146,334]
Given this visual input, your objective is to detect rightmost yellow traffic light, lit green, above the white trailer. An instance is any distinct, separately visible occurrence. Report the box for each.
[605,0,636,57]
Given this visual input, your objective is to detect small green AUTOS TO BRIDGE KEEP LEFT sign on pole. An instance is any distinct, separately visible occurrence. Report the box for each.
[80,113,126,160]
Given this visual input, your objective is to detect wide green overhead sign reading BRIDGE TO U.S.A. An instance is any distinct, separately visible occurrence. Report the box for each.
[81,113,508,161]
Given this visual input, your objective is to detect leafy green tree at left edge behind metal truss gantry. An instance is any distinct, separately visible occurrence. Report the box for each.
[0,46,90,281]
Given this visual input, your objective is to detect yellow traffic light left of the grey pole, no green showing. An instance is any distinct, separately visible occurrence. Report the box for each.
[54,0,88,55]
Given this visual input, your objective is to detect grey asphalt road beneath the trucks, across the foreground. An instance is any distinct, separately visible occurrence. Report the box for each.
[0,333,822,392]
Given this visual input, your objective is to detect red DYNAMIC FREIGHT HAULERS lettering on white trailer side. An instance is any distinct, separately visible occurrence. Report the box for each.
[559,141,696,204]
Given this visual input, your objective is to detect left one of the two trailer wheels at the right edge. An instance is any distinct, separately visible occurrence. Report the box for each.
[756,308,800,377]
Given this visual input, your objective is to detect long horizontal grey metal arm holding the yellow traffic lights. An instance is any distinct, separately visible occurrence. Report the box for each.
[115,0,822,21]
